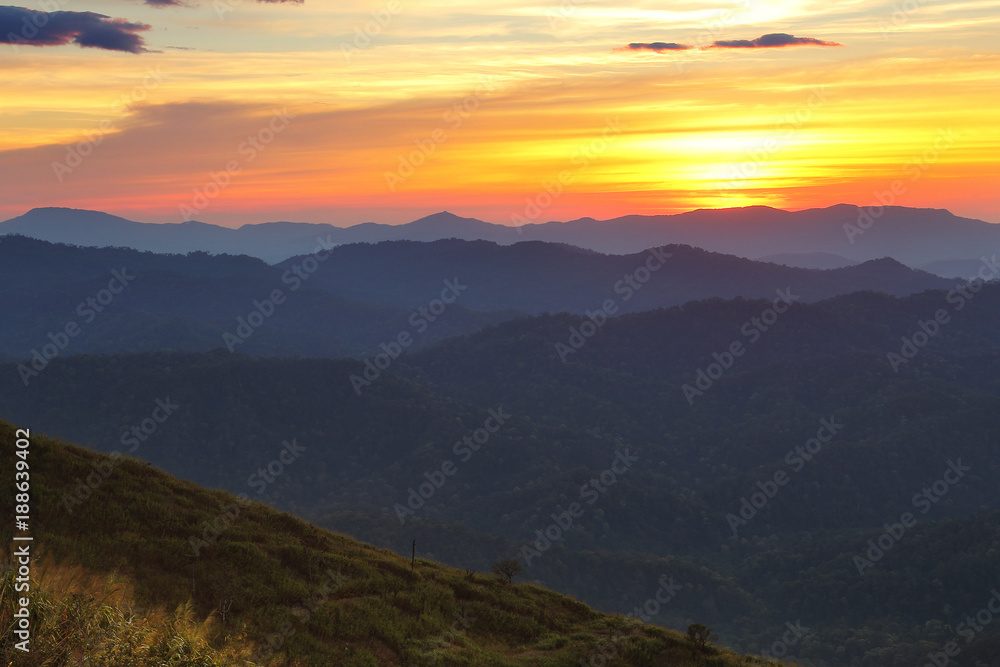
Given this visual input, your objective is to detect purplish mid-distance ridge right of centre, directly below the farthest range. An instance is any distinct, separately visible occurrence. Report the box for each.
[278,240,954,313]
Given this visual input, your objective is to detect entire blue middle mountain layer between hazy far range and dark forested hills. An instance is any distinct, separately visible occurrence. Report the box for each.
[0,236,952,365]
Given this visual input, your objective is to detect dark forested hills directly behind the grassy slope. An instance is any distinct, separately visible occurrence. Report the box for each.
[0,285,1000,667]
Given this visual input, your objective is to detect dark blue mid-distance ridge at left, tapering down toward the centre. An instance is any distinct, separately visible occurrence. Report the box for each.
[0,236,515,366]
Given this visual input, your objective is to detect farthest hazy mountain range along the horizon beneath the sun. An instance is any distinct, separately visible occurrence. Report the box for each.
[0,204,1000,277]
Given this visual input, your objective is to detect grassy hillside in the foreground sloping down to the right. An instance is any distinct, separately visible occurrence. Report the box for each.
[0,422,776,667]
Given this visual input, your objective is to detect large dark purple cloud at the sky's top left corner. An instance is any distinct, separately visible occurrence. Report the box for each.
[0,6,150,53]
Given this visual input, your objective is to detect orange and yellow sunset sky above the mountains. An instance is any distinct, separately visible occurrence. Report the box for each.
[0,0,1000,226]
